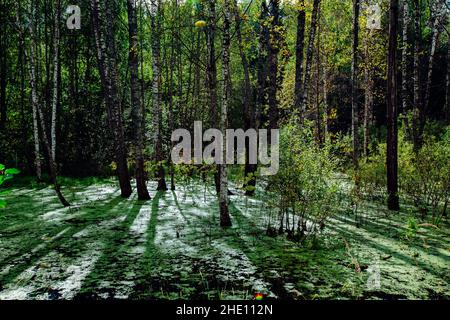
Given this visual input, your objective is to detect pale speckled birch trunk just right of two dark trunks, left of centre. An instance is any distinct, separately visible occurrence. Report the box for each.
[151,0,167,191]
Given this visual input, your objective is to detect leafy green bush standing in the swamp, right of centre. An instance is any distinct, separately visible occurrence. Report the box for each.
[268,124,338,240]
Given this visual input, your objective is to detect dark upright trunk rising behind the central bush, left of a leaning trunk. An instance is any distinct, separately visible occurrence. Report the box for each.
[294,0,306,122]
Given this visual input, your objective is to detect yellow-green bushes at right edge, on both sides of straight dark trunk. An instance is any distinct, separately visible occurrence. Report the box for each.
[359,128,450,218]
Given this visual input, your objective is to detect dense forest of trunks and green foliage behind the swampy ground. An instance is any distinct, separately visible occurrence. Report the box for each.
[0,0,450,298]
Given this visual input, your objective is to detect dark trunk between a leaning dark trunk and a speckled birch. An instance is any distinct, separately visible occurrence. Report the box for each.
[127,0,150,200]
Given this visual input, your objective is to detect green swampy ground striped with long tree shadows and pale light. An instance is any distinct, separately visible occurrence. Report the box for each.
[0,179,450,300]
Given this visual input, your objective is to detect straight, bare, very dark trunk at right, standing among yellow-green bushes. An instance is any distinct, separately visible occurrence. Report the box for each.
[386,0,400,210]
